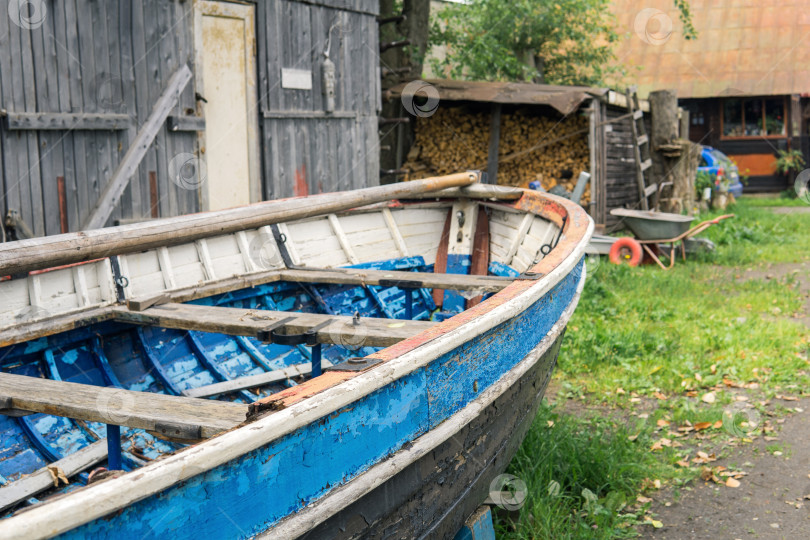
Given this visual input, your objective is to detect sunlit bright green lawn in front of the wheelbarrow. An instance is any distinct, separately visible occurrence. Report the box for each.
[556,202,810,403]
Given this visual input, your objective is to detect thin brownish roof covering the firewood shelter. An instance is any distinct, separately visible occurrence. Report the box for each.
[386,79,607,114]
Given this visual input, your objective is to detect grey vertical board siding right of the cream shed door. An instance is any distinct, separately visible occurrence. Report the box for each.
[257,0,380,199]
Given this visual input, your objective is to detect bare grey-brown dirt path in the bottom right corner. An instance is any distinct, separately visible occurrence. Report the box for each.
[642,399,810,540]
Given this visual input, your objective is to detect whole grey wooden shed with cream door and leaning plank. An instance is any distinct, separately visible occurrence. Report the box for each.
[0,0,380,237]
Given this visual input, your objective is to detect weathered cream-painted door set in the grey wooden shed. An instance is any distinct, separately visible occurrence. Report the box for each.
[194,1,261,210]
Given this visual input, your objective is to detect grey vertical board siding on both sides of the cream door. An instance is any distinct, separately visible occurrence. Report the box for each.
[0,0,380,235]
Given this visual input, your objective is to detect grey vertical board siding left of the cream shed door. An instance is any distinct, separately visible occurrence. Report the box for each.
[0,0,197,235]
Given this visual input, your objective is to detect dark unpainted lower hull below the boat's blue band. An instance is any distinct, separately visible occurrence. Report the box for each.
[301,335,562,540]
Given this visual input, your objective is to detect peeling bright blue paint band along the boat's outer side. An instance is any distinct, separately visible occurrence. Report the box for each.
[53,263,582,538]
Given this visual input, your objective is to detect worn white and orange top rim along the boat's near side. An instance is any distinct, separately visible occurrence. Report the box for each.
[0,191,593,537]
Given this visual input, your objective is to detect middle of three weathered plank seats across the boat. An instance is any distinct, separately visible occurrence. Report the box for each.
[112,304,436,348]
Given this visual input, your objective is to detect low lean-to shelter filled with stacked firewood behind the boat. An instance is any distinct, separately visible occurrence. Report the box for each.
[384,80,649,225]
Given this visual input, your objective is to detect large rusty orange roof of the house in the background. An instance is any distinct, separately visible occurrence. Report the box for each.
[613,0,810,98]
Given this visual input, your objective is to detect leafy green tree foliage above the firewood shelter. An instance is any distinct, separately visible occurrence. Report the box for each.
[430,0,620,85]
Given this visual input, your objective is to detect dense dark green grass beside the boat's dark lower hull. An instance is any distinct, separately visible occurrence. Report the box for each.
[496,405,686,539]
